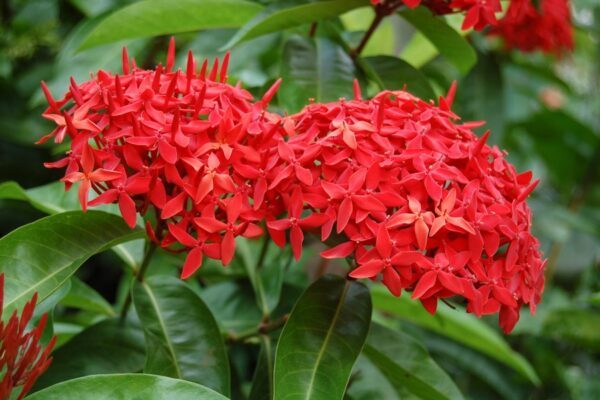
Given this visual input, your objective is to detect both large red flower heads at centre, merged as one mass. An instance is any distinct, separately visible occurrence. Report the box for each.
[37,41,544,332]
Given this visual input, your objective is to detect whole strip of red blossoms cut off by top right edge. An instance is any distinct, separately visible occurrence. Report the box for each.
[371,0,573,55]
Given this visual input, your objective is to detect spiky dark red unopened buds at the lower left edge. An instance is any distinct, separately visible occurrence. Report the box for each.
[0,274,56,400]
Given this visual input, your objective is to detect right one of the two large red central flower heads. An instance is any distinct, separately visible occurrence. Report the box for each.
[267,85,544,332]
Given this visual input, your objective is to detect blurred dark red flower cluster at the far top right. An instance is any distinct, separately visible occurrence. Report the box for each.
[490,0,573,55]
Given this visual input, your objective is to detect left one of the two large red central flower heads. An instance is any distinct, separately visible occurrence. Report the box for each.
[39,39,280,278]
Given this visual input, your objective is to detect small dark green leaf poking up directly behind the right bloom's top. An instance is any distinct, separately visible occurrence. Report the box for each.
[360,56,435,100]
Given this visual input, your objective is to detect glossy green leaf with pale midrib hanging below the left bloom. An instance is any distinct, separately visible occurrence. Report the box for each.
[132,276,230,395]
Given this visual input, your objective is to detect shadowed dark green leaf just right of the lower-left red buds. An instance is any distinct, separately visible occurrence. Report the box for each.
[35,318,146,390]
